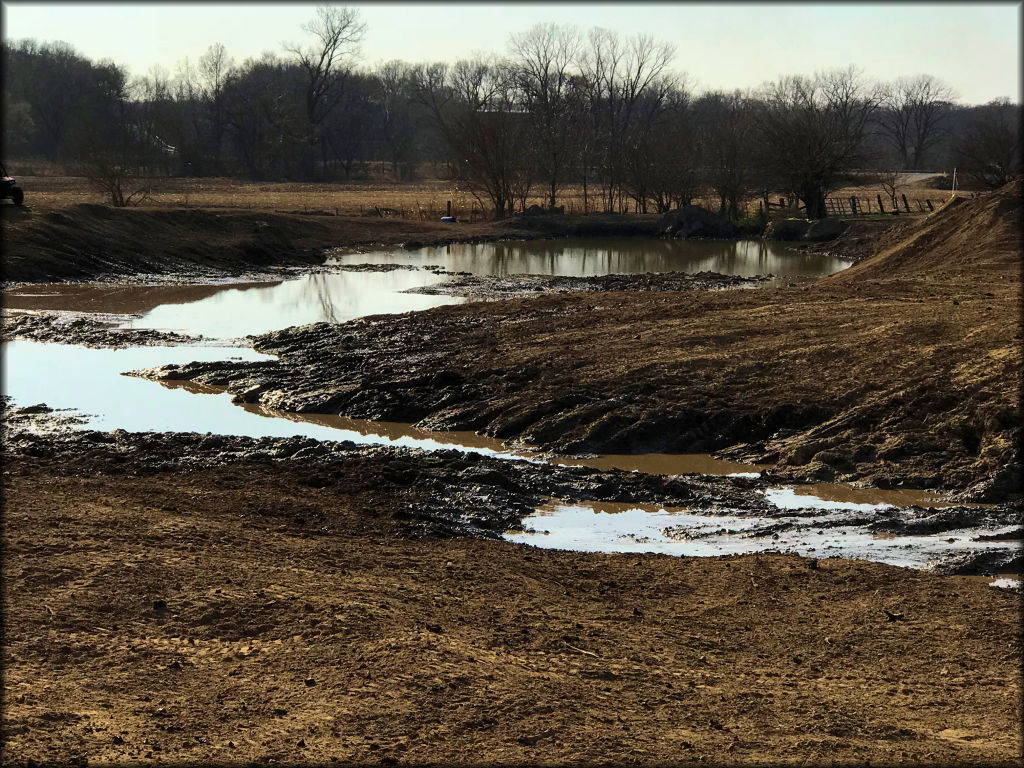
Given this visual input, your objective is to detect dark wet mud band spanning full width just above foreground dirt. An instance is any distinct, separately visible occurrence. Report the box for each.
[4,403,1022,573]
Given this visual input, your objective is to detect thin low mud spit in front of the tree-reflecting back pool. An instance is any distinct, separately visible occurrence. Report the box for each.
[408,272,771,299]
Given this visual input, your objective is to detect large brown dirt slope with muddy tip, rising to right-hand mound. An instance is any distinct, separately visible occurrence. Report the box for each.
[132,187,1021,501]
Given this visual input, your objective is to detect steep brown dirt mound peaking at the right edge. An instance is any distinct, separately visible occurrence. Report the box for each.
[828,179,1022,284]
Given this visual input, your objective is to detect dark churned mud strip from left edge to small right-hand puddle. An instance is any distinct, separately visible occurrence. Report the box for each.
[3,406,771,538]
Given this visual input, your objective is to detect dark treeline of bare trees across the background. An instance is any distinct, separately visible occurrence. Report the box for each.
[3,6,1021,218]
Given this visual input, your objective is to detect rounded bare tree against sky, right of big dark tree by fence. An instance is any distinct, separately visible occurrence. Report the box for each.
[878,75,955,170]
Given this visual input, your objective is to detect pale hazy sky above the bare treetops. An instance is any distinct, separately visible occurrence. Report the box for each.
[3,0,1022,103]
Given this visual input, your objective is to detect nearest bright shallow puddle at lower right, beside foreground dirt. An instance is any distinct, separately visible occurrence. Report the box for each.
[505,499,1015,568]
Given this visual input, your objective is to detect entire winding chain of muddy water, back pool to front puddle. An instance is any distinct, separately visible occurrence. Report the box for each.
[3,239,1015,567]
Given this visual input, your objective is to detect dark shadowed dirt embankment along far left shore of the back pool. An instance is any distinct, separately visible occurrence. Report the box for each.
[2,204,658,283]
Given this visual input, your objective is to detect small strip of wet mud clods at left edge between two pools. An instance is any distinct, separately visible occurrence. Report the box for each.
[2,310,201,348]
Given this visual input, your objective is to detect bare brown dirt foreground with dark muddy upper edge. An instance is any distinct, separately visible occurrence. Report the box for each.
[2,405,1021,765]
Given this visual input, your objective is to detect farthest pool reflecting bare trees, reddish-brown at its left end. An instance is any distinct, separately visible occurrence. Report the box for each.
[3,239,848,339]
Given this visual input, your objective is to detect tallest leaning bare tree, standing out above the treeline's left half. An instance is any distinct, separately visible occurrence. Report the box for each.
[285,5,367,176]
